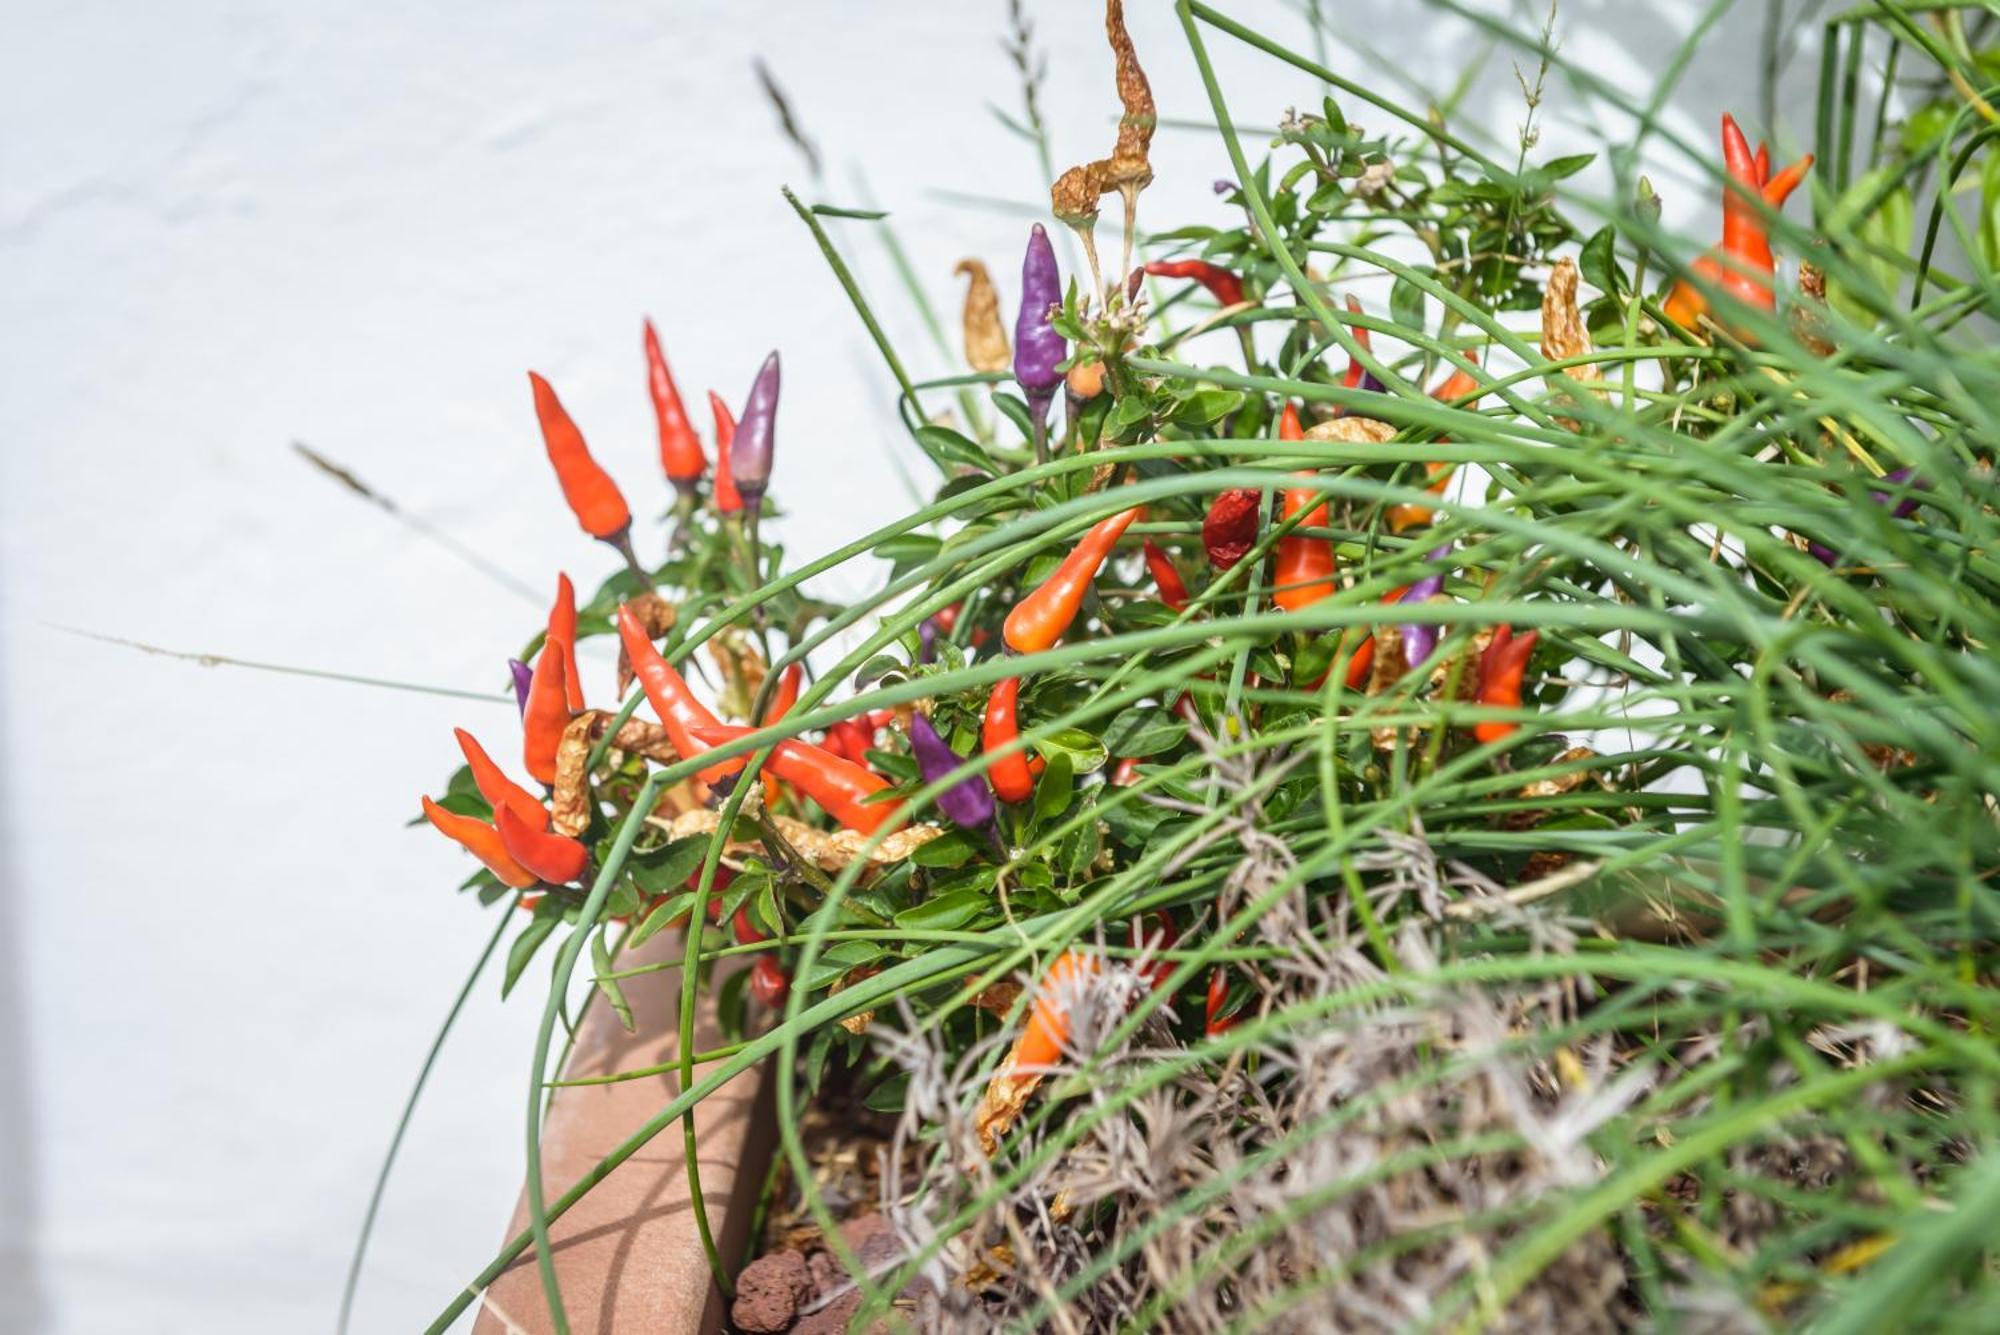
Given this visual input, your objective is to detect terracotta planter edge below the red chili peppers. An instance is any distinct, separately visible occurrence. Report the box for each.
[472,933,776,1335]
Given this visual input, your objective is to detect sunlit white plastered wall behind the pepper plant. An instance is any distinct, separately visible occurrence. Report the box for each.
[0,0,1810,1333]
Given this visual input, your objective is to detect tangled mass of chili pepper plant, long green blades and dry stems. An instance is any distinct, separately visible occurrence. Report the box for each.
[360,0,2000,1331]
